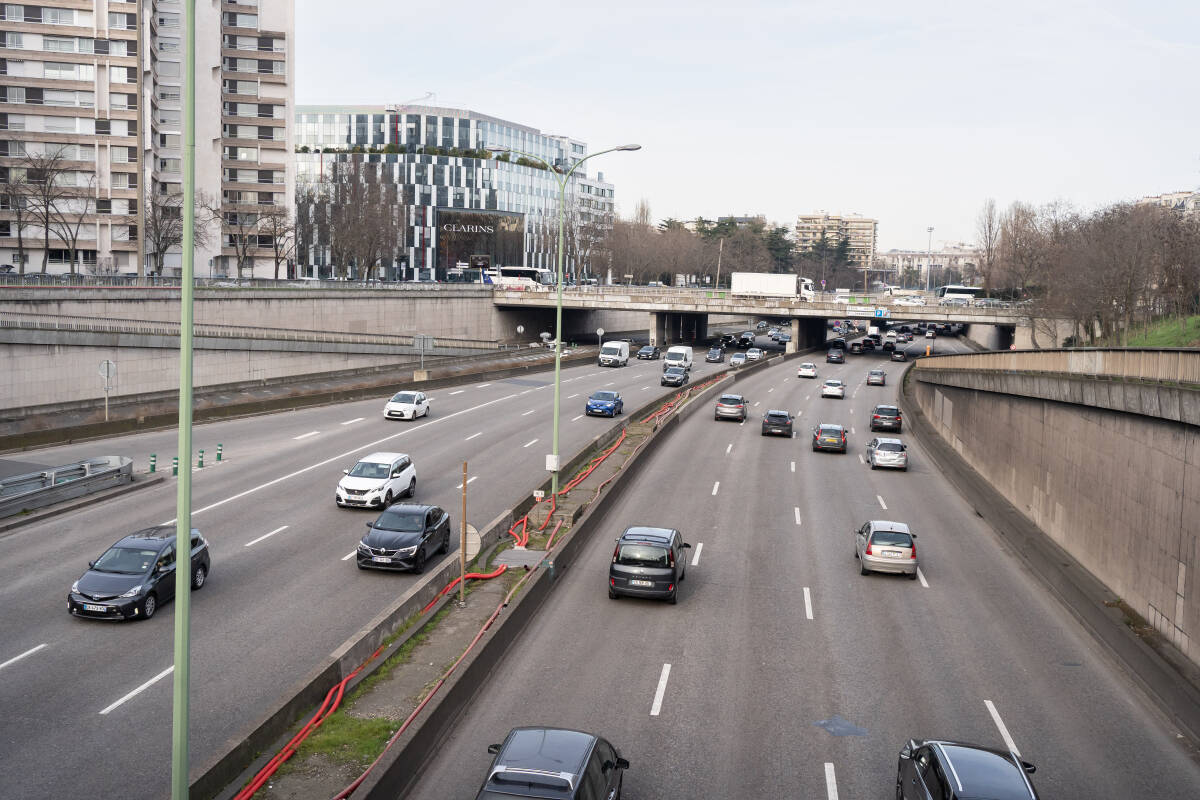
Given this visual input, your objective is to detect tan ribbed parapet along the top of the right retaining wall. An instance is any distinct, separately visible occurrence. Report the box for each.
[913,348,1200,386]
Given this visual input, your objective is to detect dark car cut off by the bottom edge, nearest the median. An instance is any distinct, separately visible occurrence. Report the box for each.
[475,728,629,800]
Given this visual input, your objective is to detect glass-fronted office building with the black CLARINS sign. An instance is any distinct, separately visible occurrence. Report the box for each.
[294,106,613,281]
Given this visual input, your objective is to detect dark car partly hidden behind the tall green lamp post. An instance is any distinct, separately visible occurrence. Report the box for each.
[67,525,211,619]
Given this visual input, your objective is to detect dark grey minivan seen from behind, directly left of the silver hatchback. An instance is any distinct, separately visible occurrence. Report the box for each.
[608,525,691,606]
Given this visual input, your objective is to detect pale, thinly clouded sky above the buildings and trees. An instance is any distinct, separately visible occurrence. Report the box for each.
[295,0,1200,251]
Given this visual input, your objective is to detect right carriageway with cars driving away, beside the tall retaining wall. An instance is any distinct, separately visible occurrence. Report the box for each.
[413,338,1200,800]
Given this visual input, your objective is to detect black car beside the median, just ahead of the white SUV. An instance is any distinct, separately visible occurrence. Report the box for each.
[358,503,450,573]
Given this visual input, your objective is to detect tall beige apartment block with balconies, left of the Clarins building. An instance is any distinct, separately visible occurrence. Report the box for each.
[0,0,294,277]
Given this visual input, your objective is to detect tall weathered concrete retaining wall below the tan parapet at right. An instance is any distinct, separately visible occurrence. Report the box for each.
[911,379,1200,663]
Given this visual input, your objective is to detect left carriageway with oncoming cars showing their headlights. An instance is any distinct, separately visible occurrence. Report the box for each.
[0,340,739,799]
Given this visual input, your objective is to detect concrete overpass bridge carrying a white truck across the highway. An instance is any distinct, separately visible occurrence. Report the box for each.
[492,285,1030,353]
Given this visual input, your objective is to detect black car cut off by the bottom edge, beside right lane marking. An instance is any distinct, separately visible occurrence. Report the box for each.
[896,739,1039,800]
